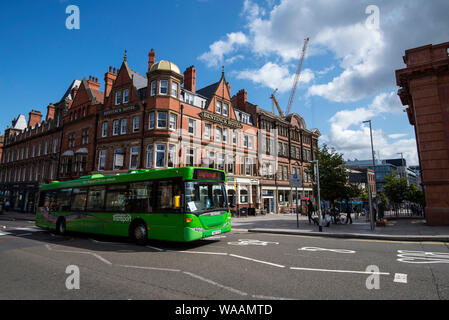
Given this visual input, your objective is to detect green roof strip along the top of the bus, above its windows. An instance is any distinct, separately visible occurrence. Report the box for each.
[41,167,226,190]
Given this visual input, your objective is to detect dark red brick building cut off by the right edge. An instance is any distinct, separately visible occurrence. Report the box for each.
[396,42,449,225]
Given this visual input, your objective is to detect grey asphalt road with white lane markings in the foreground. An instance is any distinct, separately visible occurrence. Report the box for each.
[0,221,449,300]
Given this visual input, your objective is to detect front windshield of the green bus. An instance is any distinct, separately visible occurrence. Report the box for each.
[185,181,228,214]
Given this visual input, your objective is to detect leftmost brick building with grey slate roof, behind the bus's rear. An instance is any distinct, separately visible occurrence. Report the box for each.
[0,80,79,212]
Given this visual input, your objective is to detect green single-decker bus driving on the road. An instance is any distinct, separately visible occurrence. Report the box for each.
[36,167,231,244]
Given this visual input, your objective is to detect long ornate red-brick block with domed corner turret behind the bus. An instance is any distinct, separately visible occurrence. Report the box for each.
[0,50,320,218]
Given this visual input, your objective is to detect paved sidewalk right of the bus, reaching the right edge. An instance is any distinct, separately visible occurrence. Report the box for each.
[232,214,449,242]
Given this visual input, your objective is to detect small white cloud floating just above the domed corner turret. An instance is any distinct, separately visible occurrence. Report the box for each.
[199,32,248,67]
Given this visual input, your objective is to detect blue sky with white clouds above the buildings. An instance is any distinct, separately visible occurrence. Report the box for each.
[0,0,449,164]
